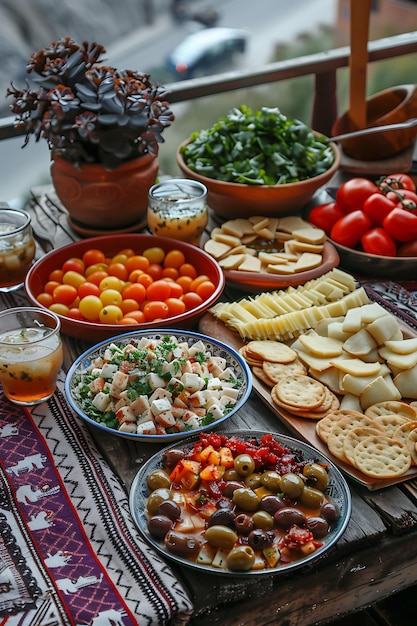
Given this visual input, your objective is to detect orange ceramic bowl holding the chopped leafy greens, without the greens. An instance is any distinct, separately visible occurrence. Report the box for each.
[177,140,340,219]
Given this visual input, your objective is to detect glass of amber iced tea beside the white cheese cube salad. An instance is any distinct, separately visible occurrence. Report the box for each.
[0,307,63,406]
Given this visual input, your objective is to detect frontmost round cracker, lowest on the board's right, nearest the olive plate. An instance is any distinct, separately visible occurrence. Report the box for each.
[354,435,411,479]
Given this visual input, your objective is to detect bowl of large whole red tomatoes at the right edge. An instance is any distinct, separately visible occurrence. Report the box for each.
[307,173,417,280]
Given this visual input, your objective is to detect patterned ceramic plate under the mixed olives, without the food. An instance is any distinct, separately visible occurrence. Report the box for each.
[130,431,351,576]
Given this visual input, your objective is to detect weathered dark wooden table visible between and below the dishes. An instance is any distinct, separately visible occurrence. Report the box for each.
[4,186,417,626]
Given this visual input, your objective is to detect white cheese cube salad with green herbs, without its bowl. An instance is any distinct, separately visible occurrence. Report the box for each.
[71,336,242,435]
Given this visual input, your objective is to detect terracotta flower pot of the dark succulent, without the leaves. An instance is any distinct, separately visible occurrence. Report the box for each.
[51,154,159,231]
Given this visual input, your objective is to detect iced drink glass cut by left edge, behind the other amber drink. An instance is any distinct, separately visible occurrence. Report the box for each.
[0,208,35,293]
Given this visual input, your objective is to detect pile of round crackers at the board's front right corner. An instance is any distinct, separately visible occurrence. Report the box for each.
[316,401,417,479]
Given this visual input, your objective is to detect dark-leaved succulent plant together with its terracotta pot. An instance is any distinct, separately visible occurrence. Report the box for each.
[7,37,174,229]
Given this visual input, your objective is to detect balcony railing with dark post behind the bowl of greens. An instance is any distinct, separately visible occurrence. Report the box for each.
[0,31,417,140]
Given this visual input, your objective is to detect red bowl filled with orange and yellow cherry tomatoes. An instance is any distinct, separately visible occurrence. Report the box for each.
[25,234,225,343]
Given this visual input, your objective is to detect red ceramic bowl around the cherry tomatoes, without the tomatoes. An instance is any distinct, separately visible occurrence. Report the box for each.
[25,234,225,344]
